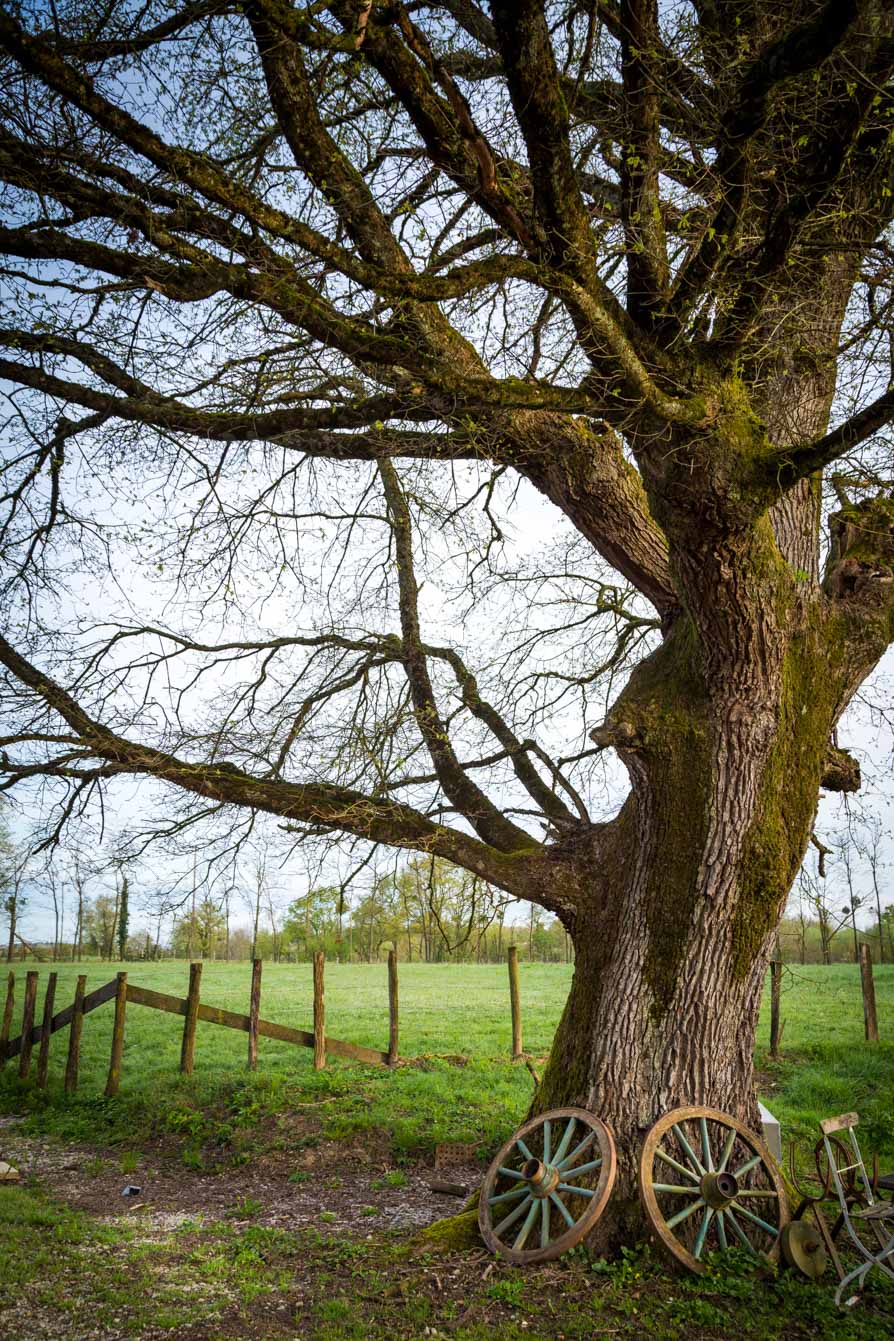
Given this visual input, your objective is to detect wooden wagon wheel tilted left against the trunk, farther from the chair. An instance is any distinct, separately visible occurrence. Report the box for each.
[478,1108,617,1266]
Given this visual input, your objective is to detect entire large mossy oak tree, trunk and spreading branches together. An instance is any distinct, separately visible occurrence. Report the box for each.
[0,0,894,1239]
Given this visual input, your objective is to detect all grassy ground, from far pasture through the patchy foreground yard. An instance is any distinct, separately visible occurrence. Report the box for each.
[0,961,894,1341]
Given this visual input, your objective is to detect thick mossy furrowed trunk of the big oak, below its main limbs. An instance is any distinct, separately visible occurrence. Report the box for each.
[536,590,848,1250]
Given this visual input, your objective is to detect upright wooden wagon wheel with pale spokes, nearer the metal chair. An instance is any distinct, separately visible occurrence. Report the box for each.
[639,1108,789,1271]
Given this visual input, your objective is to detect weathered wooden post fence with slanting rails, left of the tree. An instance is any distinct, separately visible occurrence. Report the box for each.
[0,951,398,1097]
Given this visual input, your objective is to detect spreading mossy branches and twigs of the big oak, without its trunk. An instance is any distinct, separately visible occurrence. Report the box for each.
[0,0,894,921]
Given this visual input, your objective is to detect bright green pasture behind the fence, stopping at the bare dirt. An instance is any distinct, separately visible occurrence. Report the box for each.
[0,961,894,1163]
